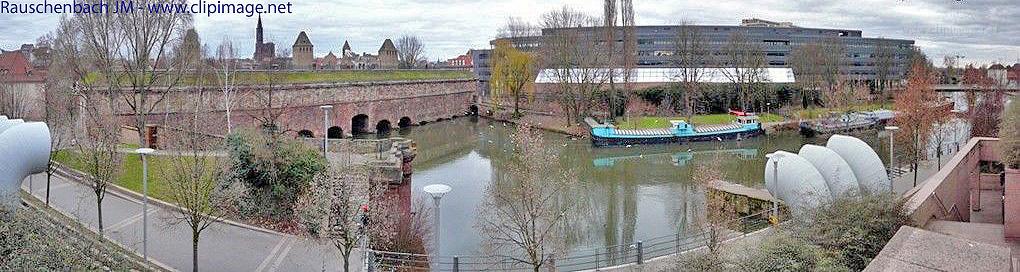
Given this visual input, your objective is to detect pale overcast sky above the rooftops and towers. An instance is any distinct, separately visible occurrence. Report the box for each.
[0,0,1020,65]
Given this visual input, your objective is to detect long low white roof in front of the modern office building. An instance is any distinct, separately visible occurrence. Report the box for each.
[534,67,796,84]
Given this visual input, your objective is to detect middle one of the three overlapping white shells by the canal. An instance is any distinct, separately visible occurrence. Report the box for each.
[798,145,859,198]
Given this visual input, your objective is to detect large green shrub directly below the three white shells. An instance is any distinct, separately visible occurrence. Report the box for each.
[797,194,913,271]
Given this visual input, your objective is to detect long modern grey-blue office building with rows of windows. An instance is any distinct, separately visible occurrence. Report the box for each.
[475,19,914,92]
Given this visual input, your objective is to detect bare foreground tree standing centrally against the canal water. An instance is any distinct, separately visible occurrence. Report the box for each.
[475,123,578,271]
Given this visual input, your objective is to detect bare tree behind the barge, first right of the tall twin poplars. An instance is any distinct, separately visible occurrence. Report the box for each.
[670,21,709,121]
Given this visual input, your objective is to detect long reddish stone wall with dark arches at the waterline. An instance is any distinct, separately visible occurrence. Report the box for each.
[111,79,477,138]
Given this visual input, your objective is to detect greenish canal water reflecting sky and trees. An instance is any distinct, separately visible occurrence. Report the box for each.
[385,92,969,256]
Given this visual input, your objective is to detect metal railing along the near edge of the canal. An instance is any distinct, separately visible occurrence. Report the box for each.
[366,210,771,272]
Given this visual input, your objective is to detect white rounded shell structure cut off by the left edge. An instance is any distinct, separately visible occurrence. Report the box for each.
[0,116,50,207]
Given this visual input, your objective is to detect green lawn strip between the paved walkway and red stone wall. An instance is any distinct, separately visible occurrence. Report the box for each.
[53,150,213,202]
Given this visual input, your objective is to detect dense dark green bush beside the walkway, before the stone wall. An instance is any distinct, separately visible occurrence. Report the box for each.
[226,130,326,221]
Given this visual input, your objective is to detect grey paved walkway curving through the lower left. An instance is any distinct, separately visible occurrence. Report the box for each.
[22,174,361,272]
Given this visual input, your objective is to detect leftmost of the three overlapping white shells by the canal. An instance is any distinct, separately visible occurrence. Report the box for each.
[765,151,832,214]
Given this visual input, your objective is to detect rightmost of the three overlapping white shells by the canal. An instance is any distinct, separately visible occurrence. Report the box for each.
[825,134,890,193]
